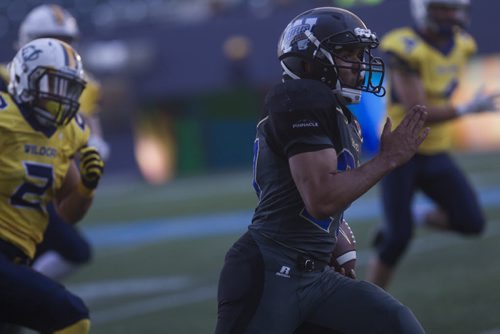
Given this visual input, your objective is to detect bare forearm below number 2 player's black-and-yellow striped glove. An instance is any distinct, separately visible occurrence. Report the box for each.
[57,185,93,224]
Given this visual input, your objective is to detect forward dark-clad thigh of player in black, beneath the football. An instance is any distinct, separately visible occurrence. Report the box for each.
[307,272,424,334]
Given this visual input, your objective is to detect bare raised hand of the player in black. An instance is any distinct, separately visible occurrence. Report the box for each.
[379,105,429,168]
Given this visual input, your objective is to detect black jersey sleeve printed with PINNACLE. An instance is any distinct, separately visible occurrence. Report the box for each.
[266,80,336,158]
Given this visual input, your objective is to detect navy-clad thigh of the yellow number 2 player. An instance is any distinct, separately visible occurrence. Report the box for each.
[0,255,88,332]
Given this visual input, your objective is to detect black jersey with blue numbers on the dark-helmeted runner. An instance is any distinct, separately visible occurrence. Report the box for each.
[249,79,362,261]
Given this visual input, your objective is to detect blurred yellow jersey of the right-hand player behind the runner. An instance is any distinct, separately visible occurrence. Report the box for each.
[380,27,477,154]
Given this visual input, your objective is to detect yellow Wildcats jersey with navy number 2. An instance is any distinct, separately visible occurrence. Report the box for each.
[0,92,89,258]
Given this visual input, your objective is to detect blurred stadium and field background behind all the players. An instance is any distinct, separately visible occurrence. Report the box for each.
[0,0,500,334]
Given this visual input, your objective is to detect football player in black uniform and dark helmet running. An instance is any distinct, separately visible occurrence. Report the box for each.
[216,7,428,334]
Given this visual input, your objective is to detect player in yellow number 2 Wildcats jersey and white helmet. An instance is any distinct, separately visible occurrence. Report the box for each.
[0,38,104,334]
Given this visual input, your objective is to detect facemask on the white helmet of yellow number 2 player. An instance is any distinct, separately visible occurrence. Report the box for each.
[26,67,85,127]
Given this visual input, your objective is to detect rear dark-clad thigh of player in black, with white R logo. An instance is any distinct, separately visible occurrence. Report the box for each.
[216,235,301,334]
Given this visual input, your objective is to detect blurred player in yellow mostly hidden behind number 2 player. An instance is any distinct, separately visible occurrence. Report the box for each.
[8,4,110,279]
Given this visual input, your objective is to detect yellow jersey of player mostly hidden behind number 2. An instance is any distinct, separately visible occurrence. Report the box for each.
[0,64,101,117]
